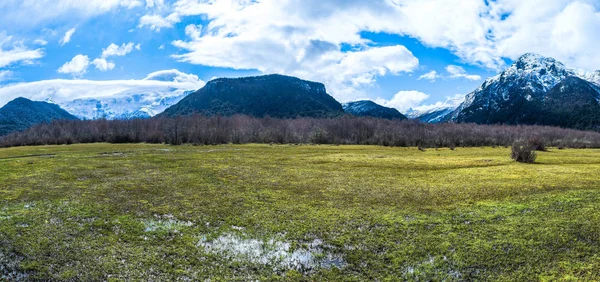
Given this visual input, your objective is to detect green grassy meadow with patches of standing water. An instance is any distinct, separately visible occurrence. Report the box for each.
[0,144,600,281]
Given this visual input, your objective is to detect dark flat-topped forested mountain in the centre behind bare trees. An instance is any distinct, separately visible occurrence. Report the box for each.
[161,75,344,118]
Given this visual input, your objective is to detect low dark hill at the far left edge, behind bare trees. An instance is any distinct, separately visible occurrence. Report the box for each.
[0,98,77,136]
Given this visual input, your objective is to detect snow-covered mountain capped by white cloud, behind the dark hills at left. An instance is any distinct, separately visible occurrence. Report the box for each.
[0,70,205,119]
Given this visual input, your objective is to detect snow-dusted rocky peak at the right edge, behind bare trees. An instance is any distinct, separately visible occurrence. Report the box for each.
[451,54,600,130]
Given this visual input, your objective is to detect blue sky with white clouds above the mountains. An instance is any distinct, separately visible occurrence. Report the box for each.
[0,0,600,112]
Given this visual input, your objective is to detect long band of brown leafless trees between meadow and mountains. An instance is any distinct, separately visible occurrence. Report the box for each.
[0,115,600,148]
